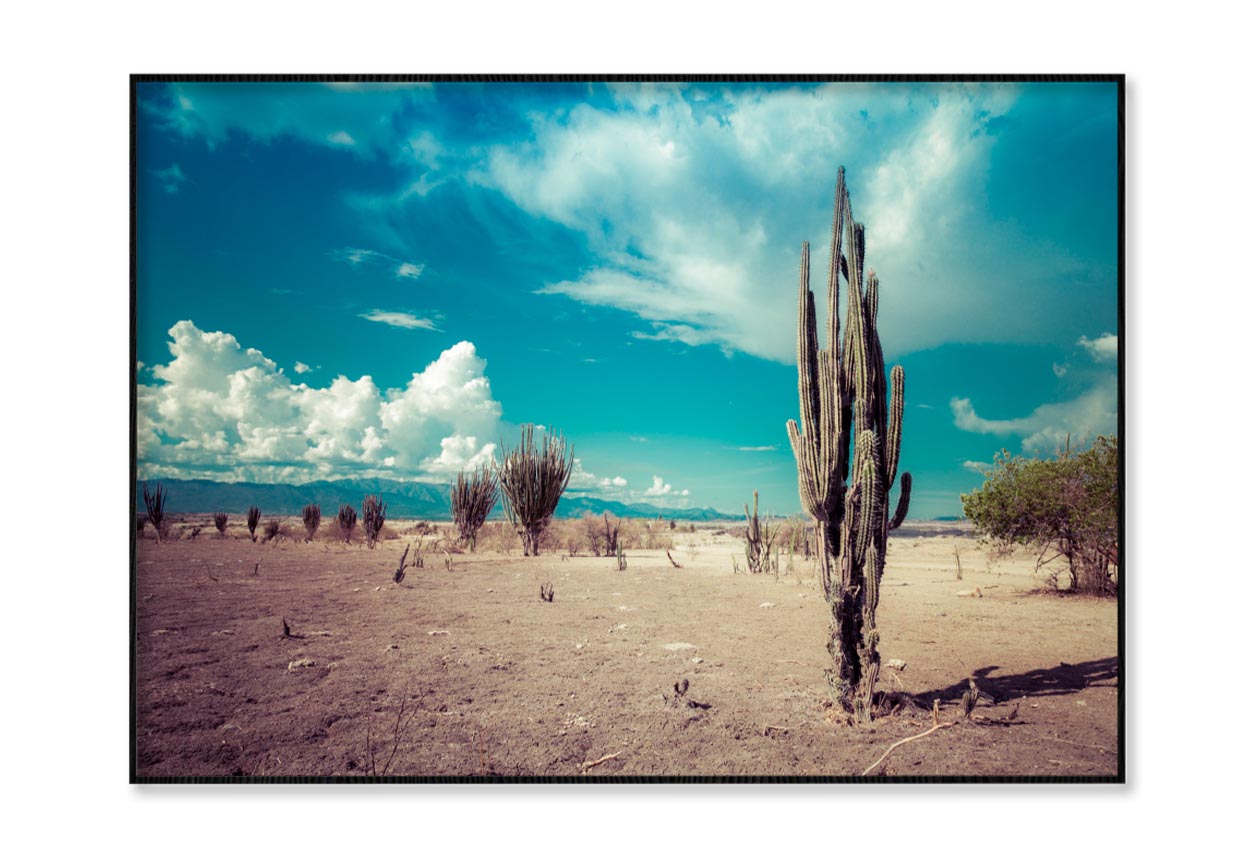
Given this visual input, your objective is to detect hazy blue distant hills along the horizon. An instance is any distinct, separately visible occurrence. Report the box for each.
[135,478,739,521]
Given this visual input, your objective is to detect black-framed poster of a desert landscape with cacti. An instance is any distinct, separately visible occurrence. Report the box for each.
[128,75,1125,782]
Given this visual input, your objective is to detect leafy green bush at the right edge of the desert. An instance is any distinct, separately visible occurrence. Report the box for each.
[961,436,1119,595]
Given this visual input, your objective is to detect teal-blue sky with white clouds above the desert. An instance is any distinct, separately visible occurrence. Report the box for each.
[135,83,1119,517]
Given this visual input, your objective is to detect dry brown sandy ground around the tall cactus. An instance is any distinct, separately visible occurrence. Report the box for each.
[134,524,1119,778]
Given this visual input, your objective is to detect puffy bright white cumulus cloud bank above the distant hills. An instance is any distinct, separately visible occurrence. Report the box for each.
[137,321,500,482]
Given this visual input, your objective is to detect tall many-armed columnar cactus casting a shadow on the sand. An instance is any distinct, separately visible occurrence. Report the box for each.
[787,167,912,721]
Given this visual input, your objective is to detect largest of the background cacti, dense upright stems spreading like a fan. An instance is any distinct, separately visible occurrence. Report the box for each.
[497,423,574,556]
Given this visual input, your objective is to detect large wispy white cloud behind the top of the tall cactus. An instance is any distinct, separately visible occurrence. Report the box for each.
[472,78,1052,362]
